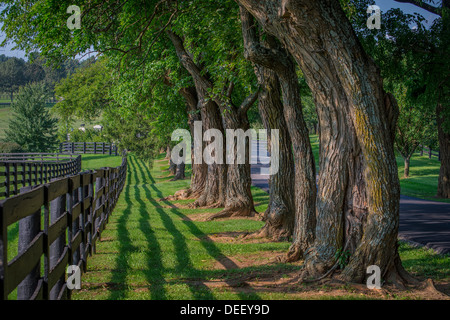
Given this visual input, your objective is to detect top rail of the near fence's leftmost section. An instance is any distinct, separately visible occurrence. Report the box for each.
[3,186,44,226]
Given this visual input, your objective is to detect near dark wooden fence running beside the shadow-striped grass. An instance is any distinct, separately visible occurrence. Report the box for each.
[0,156,127,300]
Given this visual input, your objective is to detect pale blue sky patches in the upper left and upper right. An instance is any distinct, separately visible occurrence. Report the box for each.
[0,0,438,59]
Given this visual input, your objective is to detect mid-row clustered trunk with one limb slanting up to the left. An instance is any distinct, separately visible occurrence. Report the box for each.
[166,31,256,218]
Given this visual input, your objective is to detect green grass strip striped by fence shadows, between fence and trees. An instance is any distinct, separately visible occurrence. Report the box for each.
[72,155,450,300]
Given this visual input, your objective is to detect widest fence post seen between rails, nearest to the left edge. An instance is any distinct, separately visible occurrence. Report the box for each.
[17,187,41,300]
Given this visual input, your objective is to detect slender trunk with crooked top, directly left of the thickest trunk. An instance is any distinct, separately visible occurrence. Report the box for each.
[241,7,316,250]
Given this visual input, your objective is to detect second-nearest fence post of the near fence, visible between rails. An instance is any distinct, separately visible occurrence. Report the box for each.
[49,189,66,300]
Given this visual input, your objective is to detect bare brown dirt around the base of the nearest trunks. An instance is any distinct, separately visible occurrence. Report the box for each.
[194,248,450,300]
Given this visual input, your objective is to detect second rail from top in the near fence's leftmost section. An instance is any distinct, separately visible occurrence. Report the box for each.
[5,231,44,294]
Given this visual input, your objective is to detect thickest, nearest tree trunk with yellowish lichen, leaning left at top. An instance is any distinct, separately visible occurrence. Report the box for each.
[239,0,407,282]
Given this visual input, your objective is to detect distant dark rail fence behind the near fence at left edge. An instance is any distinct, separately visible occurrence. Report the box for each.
[0,153,81,198]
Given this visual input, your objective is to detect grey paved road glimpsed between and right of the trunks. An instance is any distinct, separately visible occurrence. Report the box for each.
[251,141,450,254]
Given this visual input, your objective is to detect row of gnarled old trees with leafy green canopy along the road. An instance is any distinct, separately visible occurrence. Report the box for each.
[1,0,449,285]
